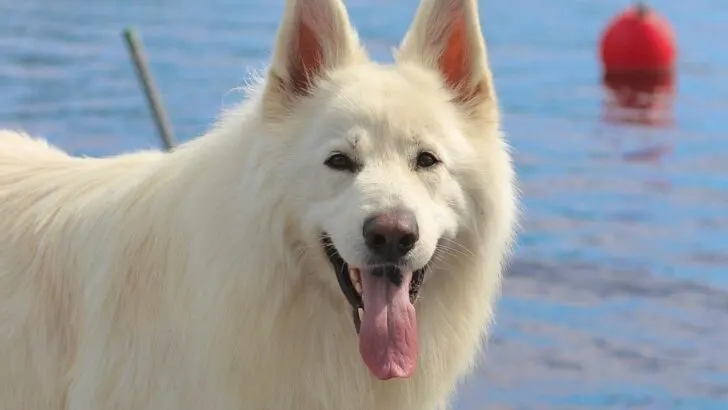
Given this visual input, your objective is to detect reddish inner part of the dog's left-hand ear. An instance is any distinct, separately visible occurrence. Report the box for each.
[289,22,323,95]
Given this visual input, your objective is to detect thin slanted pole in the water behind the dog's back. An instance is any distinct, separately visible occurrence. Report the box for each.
[124,28,175,151]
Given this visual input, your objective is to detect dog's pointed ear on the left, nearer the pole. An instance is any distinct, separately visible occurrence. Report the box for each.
[264,0,366,113]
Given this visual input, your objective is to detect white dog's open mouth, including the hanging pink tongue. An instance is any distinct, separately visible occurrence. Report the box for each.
[321,234,427,380]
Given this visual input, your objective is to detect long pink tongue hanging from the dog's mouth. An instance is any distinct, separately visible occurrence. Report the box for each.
[359,270,419,380]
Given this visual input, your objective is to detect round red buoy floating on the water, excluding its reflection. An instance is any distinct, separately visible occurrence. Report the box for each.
[600,3,676,76]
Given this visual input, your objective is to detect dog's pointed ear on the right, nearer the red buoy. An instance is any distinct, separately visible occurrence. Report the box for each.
[396,0,496,106]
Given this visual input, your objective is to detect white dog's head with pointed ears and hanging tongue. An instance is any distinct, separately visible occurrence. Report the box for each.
[262,0,503,379]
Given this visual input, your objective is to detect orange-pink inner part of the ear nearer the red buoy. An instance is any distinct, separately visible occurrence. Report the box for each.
[438,11,480,102]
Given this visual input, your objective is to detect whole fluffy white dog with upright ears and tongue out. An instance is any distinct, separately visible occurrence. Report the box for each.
[0,0,517,410]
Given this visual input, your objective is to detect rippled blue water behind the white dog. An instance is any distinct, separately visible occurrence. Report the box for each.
[0,0,728,410]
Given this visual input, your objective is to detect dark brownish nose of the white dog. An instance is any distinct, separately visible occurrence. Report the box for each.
[362,209,420,263]
